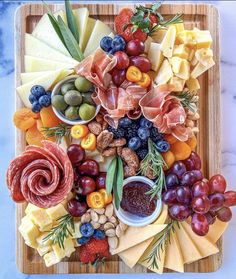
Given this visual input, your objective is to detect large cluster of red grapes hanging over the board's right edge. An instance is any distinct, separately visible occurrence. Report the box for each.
[162,152,236,236]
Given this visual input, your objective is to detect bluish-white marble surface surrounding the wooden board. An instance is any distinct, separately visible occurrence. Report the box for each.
[0,0,236,279]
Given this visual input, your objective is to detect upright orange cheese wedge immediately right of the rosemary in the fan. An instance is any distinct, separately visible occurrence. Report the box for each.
[165,231,184,272]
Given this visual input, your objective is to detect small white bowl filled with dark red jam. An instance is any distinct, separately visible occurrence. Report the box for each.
[116,176,162,227]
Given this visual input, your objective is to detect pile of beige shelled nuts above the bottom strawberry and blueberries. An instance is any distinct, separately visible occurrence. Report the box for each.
[81,203,128,252]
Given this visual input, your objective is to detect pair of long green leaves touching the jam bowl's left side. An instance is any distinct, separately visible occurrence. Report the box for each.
[106,156,124,209]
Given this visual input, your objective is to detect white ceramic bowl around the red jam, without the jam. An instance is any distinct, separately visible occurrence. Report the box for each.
[114,176,162,227]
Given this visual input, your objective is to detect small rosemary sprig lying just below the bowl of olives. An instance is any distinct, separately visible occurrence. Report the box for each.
[41,124,71,144]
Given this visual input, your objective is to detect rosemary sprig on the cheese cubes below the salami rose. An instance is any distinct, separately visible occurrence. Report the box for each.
[43,214,75,249]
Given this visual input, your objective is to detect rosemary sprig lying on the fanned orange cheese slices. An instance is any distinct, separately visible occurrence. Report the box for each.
[143,220,178,269]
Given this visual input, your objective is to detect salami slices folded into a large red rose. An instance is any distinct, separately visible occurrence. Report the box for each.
[7,141,74,208]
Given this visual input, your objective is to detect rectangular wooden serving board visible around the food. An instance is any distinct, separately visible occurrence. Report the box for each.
[15,3,222,274]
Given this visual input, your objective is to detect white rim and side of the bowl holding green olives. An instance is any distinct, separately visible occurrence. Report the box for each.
[52,75,101,126]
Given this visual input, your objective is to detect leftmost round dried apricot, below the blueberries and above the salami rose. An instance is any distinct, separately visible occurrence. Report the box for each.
[13,108,37,131]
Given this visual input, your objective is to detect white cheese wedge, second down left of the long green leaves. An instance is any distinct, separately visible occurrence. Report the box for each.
[25,33,78,64]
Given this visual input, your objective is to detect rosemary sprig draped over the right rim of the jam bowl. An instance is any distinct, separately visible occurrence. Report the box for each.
[140,139,166,199]
